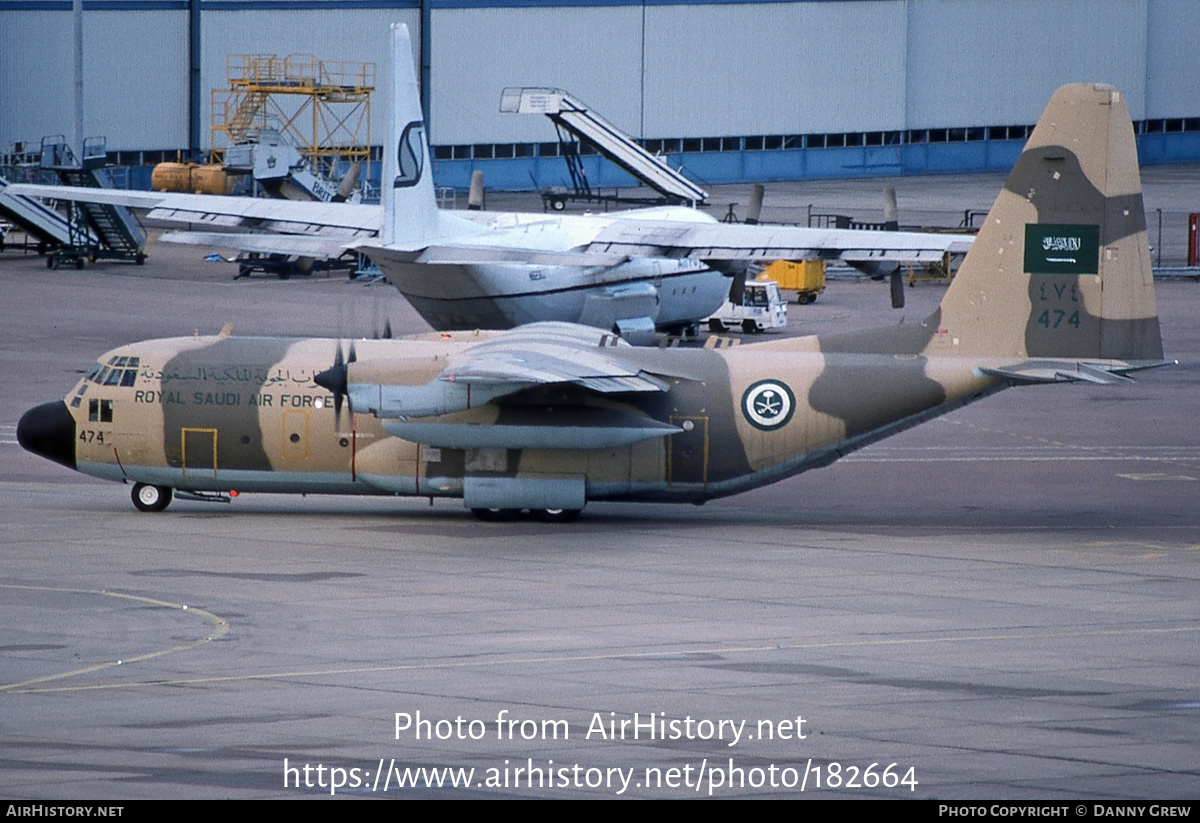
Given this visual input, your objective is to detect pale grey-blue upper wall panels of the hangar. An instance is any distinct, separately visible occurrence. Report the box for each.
[0,0,1200,150]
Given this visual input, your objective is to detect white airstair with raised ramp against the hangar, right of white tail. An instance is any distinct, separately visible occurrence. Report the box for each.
[500,89,708,209]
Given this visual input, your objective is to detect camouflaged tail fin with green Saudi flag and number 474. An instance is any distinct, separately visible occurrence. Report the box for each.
[930,84,1163,360]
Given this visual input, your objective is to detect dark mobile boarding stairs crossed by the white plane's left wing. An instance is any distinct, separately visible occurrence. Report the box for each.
[42,134,146,269]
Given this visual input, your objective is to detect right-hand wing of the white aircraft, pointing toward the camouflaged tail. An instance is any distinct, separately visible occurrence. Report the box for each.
[587,220,972,263]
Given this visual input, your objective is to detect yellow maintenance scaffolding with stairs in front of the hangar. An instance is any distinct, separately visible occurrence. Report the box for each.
[210,54,376,178]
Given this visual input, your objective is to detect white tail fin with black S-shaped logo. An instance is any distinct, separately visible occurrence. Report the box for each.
[383,23,439,247]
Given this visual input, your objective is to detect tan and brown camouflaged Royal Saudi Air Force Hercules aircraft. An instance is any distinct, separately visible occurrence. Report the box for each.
[18,85,1165,519]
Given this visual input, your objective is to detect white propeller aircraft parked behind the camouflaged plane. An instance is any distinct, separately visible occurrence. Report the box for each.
[12,25,971,342]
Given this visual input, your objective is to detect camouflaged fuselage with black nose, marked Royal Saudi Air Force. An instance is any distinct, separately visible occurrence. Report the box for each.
[19,332,996,501]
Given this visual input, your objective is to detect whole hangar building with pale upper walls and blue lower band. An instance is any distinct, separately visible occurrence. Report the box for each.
[0,0,1200,188]
